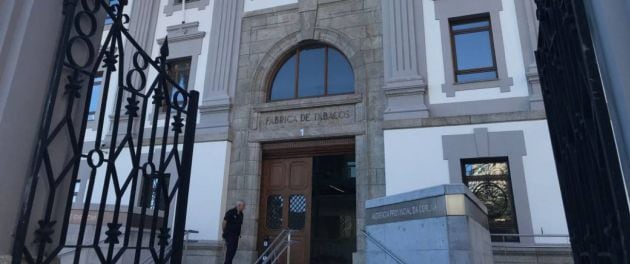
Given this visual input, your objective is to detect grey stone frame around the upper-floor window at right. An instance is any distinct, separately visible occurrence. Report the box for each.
[434,0,514,97]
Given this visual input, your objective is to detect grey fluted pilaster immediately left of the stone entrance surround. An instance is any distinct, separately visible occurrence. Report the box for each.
[197,0,244,140]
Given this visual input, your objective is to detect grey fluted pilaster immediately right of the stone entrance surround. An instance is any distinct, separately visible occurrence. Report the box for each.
[381,0,429,120]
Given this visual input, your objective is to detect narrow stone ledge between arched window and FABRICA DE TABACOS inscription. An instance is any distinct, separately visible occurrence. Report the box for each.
[254,94,363,113]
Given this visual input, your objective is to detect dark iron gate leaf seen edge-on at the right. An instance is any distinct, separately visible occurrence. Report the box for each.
[536,0,630,263]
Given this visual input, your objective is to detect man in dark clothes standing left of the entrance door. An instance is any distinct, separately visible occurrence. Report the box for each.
[223,201,245,264]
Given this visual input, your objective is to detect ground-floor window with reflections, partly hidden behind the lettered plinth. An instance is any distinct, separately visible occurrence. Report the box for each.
[461,157,519,242]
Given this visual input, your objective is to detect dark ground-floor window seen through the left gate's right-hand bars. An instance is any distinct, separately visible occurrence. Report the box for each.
[140,173,171,210]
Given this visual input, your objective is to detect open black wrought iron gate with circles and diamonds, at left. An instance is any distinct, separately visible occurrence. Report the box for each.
[13,0,199,264]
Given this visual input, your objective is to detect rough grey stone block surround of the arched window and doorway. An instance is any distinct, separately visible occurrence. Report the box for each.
[227,0,385,263]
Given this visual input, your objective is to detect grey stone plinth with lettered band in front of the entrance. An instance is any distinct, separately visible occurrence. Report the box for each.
[365,184,493,264]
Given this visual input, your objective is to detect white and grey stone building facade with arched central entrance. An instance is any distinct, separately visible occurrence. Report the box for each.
[65,0,570,263]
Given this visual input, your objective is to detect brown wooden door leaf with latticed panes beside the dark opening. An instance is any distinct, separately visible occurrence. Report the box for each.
[258,157,313,263]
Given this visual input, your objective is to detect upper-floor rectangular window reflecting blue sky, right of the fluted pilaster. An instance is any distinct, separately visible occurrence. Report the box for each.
[449,14,498,83]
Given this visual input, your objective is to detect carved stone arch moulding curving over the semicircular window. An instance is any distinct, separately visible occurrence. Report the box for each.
[250,28,366,104]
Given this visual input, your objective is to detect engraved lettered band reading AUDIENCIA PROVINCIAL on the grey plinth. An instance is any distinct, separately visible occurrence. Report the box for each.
[365,196,446,225]
